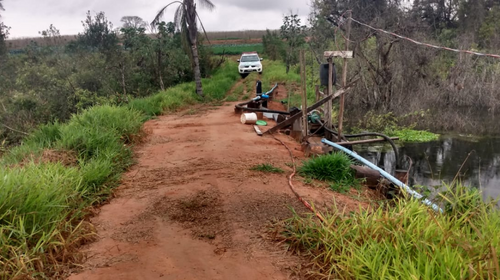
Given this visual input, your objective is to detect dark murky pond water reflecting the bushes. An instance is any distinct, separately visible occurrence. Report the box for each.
[354,136,500,199]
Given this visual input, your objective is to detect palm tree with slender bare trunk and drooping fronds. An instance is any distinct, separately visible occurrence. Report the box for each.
[150,0,215,97]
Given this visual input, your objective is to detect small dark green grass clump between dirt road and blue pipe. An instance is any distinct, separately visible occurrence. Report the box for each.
[299,153,360,192]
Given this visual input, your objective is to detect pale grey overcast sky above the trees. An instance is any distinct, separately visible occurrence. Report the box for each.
[0,0,310,38]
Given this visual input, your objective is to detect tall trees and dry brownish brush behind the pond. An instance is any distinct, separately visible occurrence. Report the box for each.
[263,0,500,134]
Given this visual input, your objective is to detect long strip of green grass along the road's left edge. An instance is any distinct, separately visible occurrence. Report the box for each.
[0,59,239,279]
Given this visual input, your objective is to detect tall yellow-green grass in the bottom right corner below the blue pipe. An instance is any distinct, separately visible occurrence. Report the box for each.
[280,185,500,280]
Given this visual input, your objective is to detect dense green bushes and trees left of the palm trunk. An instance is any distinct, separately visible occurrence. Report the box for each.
[0,12,215,145]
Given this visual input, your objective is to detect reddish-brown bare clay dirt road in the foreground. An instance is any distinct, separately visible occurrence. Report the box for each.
[69,100,376,280]
